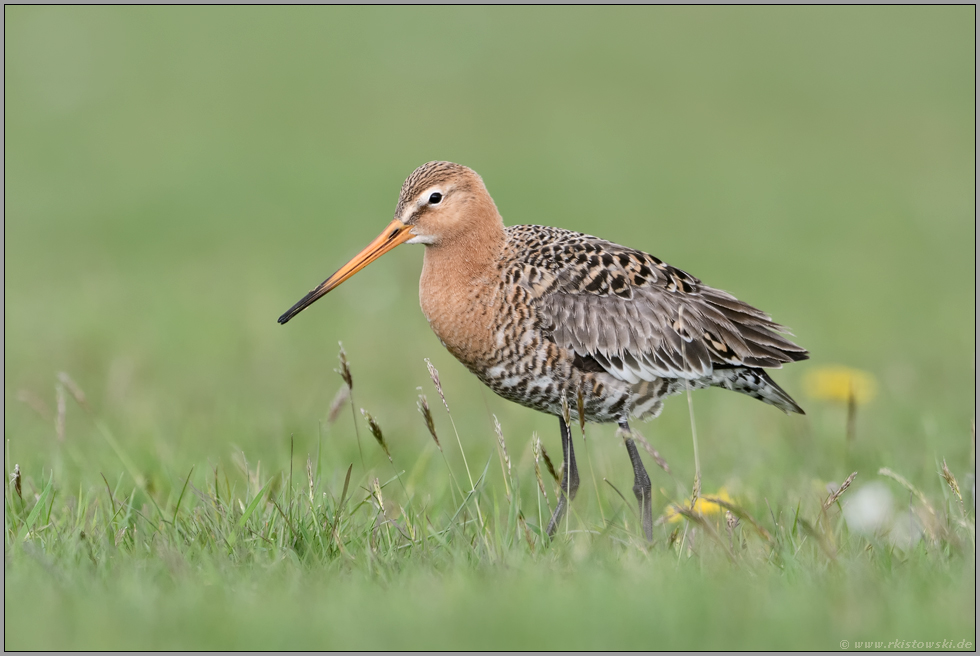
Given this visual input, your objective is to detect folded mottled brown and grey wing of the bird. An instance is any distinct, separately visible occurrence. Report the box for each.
[509,226,808,383]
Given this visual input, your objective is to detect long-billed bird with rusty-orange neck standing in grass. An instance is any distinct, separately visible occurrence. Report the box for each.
[279,161,809,541]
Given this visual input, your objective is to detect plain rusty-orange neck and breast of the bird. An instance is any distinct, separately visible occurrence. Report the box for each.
[419,208,506,368]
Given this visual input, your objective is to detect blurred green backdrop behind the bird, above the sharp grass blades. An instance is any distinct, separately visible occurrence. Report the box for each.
[4,6,976,648]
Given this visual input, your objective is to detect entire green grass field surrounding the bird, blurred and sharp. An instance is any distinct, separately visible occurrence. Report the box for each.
[4,7,976,649]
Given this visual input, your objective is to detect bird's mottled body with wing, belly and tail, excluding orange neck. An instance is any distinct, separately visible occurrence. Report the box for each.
[461,225,808,421]
